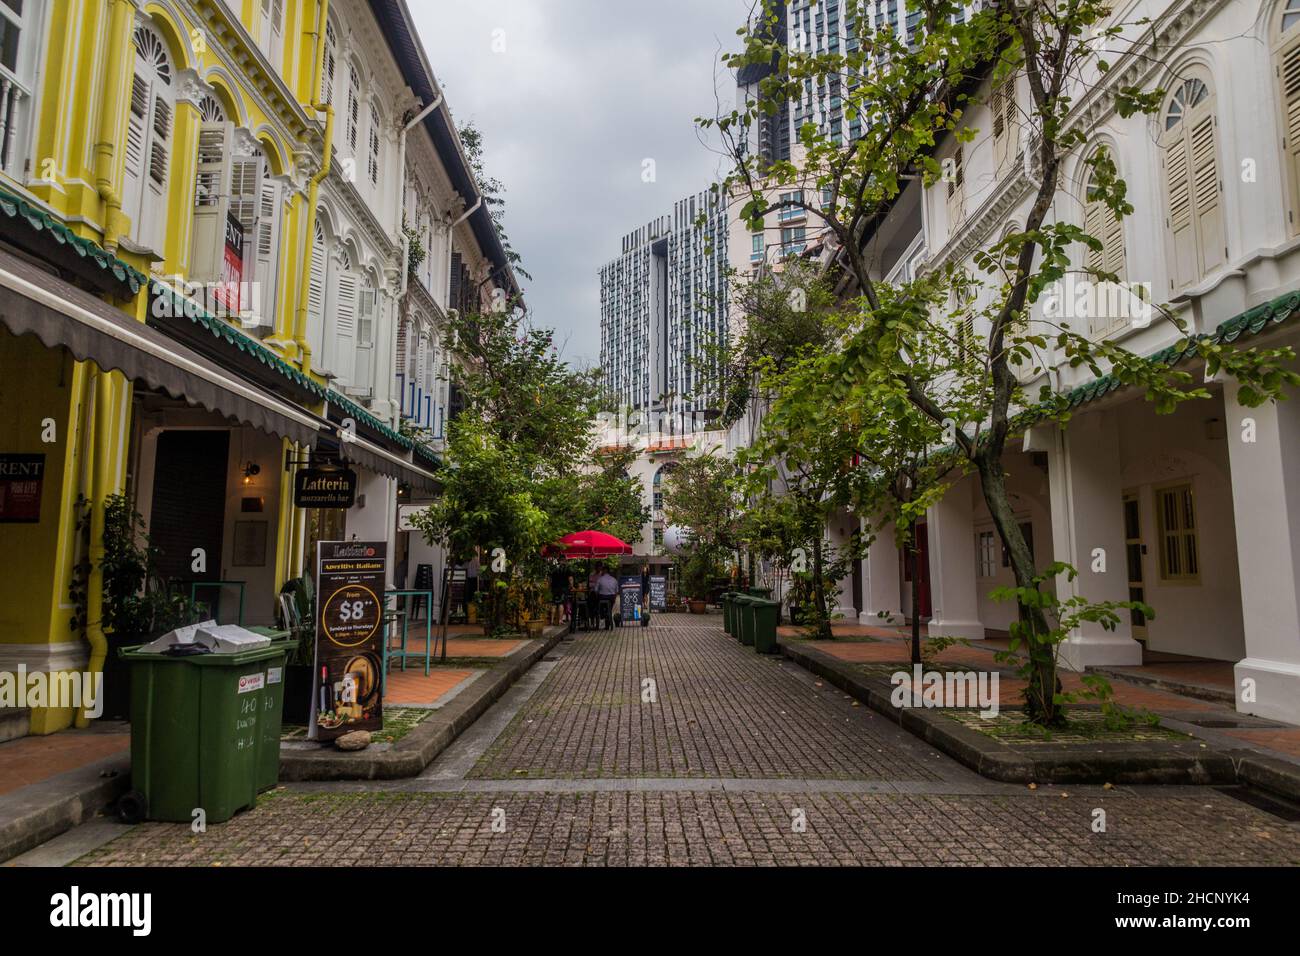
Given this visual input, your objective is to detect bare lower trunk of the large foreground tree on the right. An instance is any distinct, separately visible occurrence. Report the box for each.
[975,455,1065,727]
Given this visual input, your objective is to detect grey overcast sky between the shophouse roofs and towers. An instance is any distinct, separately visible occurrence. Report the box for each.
[408,0,750,364]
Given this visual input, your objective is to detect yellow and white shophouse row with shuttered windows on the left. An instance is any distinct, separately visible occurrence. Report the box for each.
[0,0,517,732]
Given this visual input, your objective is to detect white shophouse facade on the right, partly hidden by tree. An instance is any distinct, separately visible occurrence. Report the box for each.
[728,0,1300,723]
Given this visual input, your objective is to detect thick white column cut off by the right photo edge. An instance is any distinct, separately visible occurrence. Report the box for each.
[1223,381,1300,723]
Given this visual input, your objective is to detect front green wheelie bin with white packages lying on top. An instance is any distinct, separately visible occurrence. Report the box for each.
[118,641,291,823]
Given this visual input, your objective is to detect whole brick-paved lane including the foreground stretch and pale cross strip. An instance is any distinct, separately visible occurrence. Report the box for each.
[69,615,1300,866]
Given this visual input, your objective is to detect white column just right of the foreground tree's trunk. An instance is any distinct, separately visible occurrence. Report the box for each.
[1024,411,1141,671]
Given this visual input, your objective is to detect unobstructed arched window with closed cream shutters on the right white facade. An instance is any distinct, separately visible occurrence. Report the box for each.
[1160,68,1227,291]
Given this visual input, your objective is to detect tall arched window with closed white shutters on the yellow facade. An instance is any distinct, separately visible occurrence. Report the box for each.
[122,25,176,251]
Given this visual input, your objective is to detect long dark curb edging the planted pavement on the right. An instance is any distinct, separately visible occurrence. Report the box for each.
[776,637,1237,788]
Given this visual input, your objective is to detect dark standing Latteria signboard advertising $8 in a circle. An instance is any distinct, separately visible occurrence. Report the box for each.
[311,541,387,740]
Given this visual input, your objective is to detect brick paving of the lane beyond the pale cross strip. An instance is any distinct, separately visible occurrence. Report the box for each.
[471,615,939,780]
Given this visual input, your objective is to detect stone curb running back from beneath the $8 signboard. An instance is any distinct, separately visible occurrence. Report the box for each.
[280,624,568,783]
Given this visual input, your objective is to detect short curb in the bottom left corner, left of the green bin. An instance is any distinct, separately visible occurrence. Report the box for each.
[0,753,131,862]
